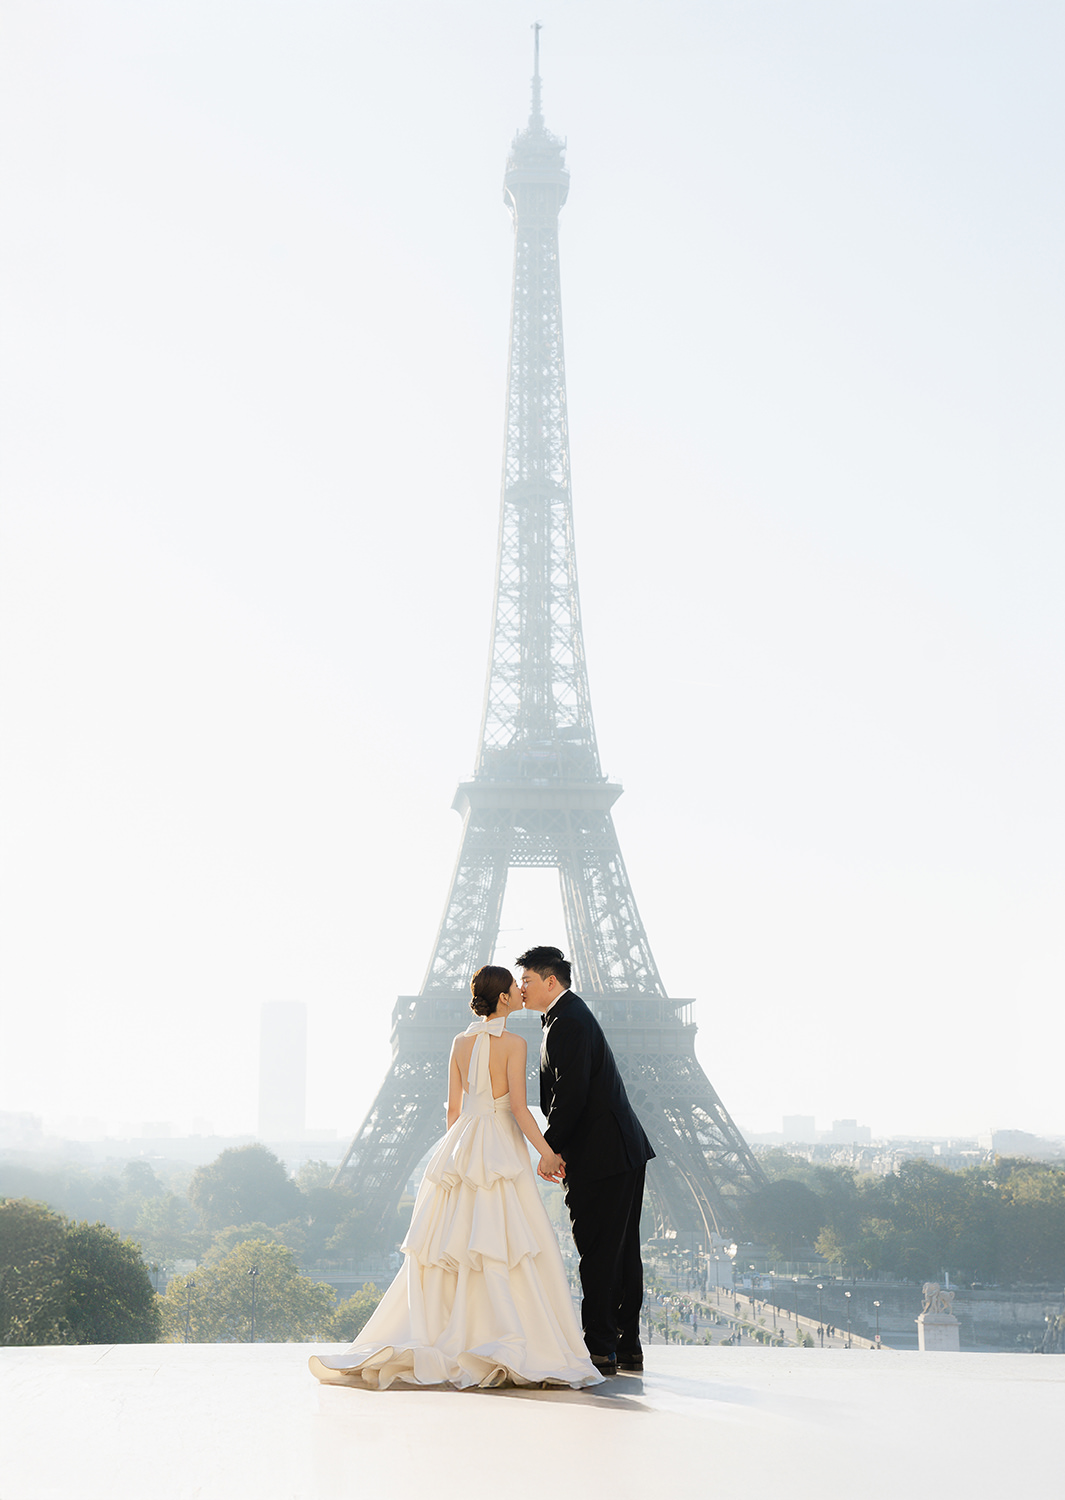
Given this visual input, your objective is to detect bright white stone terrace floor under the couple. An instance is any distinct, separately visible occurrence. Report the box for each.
[0,1344,1065,1500]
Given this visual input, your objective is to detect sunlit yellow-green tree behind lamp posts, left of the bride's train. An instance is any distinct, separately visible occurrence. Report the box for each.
[161,1239,336,1344]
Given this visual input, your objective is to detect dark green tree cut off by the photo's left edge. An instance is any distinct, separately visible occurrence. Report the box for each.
[0,1199,74,1344]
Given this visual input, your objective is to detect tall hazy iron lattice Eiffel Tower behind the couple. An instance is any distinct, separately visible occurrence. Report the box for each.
[335,26,764,1248]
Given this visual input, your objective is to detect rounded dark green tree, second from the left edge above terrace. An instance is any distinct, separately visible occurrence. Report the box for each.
[66,1224,162,1344]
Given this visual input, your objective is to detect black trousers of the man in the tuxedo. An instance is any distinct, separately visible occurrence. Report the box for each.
[566,1166,647,1359]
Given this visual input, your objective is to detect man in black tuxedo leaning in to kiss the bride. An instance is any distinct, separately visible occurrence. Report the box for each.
[518,948,654,1376]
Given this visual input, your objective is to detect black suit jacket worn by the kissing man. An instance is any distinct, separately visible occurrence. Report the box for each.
[540,990,654,1181]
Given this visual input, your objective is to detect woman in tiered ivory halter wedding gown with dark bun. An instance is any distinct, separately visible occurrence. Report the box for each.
[311,965,603,1389]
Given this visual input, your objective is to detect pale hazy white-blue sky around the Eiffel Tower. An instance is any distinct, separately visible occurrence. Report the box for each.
[0,0,1065,1134]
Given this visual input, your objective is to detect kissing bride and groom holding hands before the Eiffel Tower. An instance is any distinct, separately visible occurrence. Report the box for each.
[311,947,654,1389]
